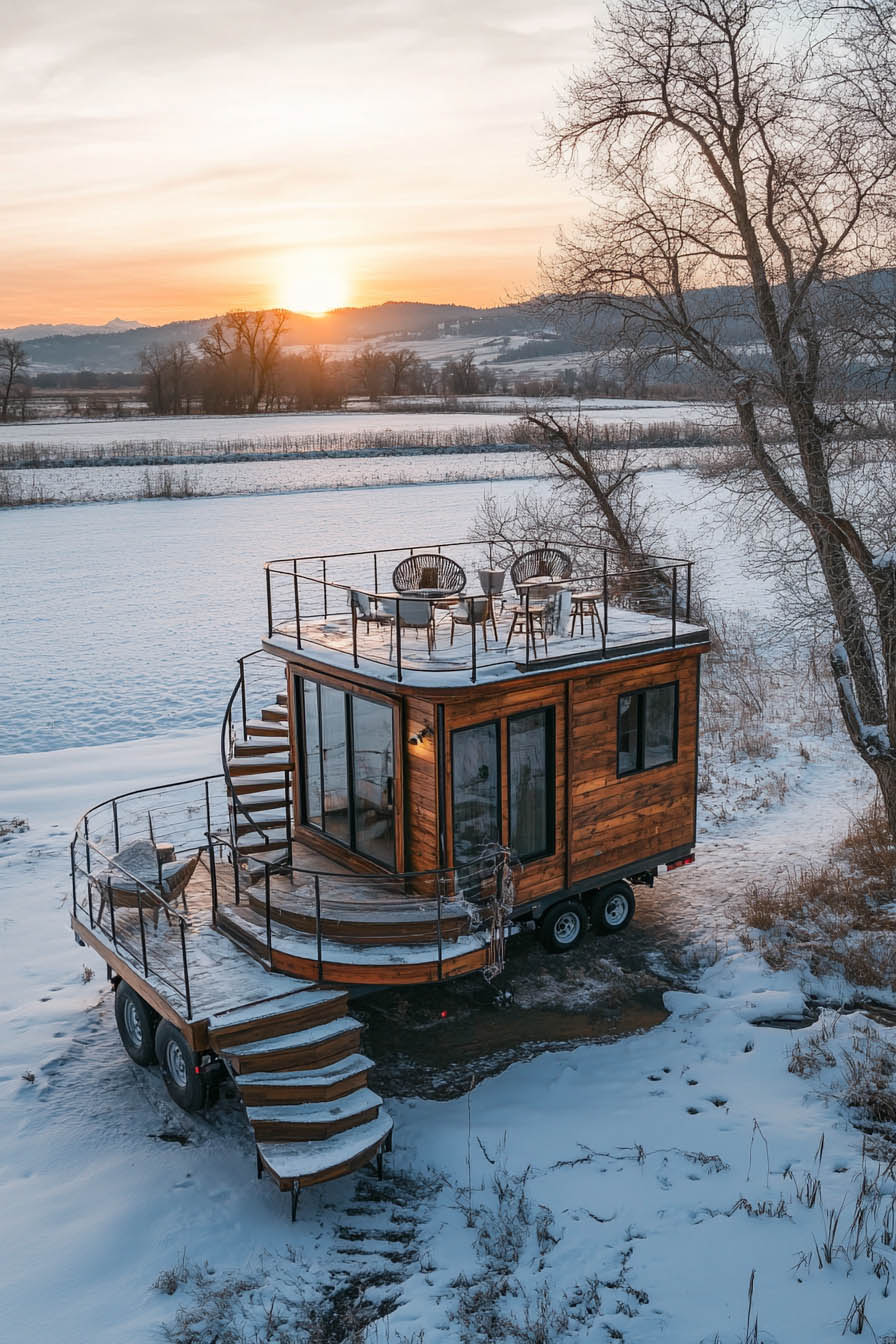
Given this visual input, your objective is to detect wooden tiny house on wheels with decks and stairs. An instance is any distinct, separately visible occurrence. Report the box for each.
[71,539,708,1218]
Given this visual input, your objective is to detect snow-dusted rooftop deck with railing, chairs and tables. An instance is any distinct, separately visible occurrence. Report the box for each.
[266,539,705,685]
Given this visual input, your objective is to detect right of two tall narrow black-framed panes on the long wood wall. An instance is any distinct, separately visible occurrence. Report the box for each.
[508,710,553,859]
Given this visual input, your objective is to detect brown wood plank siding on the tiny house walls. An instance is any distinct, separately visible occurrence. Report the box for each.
[271,644,705,905]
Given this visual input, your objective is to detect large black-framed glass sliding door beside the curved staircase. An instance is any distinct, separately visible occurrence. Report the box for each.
[297,680,395,868]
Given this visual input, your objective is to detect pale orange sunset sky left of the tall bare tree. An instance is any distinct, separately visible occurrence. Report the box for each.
[0,0,595,327]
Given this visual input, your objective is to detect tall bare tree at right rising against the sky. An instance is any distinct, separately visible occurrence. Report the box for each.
[548,0,896,836]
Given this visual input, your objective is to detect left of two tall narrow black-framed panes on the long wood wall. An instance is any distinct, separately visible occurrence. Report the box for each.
[451,723,501,864]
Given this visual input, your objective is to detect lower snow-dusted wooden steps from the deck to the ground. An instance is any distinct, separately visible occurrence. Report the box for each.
[208,981,392,1222]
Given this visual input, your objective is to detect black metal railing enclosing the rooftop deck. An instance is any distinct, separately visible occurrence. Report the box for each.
[265,538,693,681]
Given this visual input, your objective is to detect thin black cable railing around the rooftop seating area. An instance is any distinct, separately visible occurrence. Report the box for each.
[265,538,693,681]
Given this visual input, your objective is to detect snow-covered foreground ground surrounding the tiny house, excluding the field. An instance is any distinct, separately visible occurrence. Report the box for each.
[0,732,896,1344]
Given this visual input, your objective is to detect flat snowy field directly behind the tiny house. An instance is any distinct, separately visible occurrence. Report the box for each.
[0,464,760,751]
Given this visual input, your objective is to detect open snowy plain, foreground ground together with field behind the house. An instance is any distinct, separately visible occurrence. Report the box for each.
[0,448,896,1344]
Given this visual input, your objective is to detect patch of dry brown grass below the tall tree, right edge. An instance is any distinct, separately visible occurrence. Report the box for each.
[740,800,896,989]
